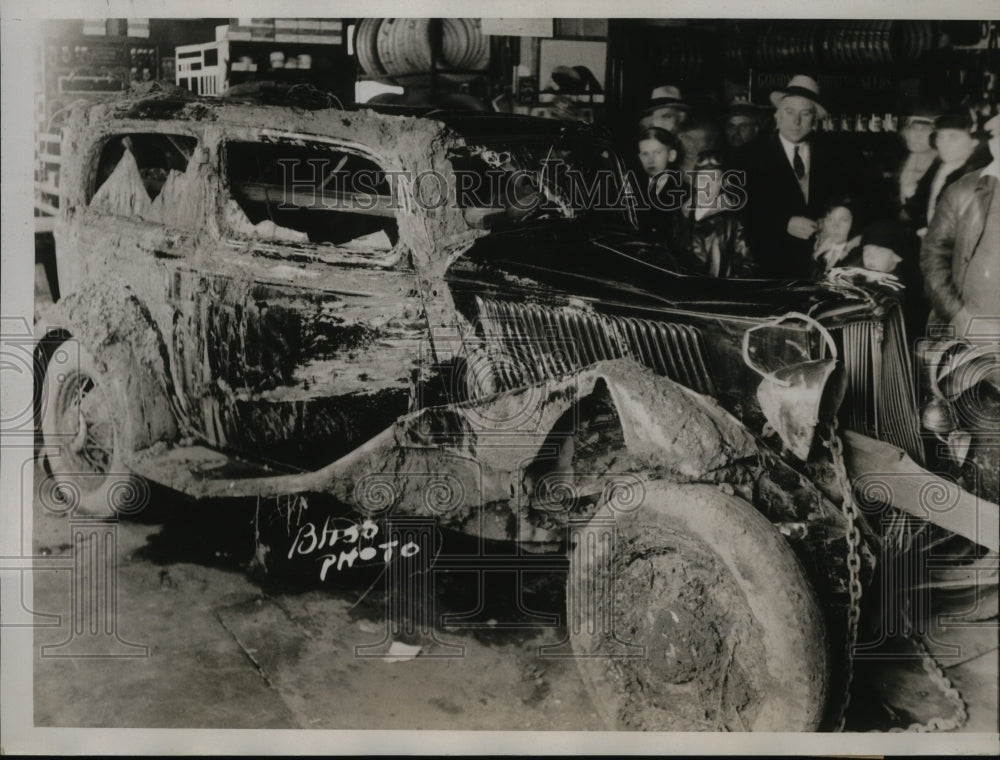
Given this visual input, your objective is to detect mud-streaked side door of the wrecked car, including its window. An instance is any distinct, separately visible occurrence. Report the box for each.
[168,130,428,469]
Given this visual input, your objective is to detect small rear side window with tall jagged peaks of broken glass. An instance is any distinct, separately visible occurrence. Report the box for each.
[90,134,206,226]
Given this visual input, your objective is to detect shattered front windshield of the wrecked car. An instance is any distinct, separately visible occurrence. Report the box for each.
[449,136,628,229]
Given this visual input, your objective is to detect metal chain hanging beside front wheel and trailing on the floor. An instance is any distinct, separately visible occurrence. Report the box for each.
[830,418,969,733]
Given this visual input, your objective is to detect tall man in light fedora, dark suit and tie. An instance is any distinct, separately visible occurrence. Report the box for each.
[745,74,843,278]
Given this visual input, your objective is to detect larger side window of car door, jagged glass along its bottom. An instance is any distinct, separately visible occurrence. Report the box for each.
[223,140,399,254]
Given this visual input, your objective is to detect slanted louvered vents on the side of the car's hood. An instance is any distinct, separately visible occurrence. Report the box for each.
[476,296,715,395]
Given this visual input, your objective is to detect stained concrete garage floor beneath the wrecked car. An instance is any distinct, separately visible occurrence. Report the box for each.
[25,460,998,732]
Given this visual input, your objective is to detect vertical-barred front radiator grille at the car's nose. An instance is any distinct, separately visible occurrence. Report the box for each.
[831,309,924,463]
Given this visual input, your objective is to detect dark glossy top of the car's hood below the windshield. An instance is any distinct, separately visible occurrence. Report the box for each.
[447,222,887,321]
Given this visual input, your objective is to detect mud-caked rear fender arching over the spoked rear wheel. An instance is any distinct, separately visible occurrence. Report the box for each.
[35,280,178,462]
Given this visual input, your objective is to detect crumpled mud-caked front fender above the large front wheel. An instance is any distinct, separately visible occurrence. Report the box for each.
[234,359,759,517]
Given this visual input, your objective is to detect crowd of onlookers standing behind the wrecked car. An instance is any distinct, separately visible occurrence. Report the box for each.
[635,75,1000,336]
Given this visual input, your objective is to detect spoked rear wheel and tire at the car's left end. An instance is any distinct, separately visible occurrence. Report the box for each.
[39,344,150,517]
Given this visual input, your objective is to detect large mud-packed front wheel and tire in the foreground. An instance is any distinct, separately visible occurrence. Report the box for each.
[567,482,829,731]
